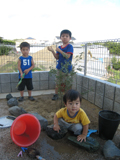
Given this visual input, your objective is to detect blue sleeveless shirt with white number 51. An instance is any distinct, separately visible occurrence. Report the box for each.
[19,56,32,79]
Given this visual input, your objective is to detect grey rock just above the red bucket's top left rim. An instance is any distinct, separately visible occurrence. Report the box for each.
[8,106,27,117]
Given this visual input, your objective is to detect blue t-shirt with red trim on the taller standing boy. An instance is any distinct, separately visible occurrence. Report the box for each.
[56,44,73,72]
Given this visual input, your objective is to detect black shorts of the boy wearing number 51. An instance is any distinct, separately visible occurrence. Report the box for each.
[18,78,33,91]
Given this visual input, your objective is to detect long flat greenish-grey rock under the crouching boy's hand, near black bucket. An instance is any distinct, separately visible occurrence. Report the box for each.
[68,136,100,152]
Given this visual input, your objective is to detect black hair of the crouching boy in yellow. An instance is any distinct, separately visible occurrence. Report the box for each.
[63,89,82,104]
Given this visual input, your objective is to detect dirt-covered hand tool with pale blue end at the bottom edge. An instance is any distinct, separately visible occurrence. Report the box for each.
[26,148,45,160]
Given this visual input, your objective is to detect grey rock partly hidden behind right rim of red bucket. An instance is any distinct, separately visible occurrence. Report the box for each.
[30,113,48,130]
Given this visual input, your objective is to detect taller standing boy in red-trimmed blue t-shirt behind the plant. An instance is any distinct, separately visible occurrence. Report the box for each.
[48,30,73,100]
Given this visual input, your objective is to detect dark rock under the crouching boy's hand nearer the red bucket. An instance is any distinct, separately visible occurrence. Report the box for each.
[46,124,68,140]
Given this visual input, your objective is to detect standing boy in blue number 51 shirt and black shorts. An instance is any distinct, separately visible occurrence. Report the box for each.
[18,42,35,101]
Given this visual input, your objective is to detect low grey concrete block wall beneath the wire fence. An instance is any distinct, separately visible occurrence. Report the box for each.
[0,71,120,113]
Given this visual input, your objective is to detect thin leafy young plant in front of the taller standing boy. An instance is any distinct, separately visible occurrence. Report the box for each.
[49,53,82,108]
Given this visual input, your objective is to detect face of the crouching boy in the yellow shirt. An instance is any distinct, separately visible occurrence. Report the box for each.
[65,97,80,115]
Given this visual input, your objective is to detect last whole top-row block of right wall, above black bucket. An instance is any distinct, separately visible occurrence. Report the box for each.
[105,84,115,100]
